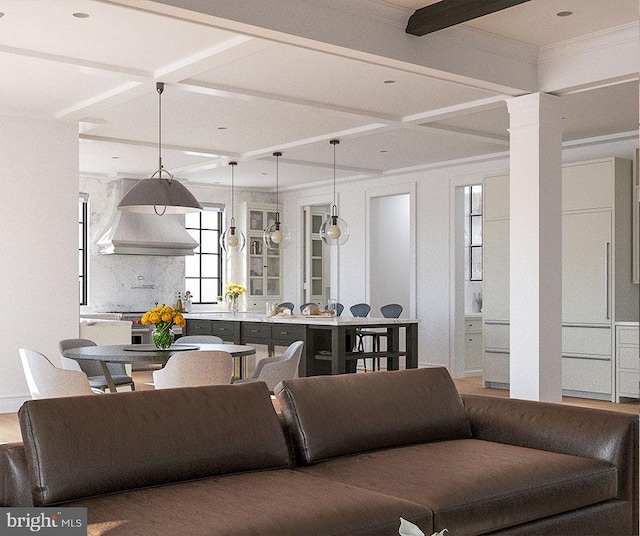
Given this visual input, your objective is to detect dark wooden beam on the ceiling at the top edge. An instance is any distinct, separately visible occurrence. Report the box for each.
[406,0,529,35]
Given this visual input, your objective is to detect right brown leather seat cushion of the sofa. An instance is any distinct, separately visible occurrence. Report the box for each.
[299,439,617,534]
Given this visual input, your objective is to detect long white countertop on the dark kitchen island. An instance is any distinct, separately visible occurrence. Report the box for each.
[184,312,418,326]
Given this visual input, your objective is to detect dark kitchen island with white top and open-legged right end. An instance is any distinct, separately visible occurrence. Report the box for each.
[184,312,418,377]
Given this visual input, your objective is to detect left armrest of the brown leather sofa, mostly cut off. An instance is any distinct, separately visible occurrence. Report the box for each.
[0,442,33,506]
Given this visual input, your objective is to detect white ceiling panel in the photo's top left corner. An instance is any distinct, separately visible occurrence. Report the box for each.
[0,0,240,72]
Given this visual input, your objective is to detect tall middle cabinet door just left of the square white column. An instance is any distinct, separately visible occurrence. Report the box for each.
[482,219,509,322]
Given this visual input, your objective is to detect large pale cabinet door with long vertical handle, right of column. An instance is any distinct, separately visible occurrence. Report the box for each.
[562,211,612,324]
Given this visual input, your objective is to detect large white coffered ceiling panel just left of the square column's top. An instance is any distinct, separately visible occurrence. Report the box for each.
[190,45,495,119]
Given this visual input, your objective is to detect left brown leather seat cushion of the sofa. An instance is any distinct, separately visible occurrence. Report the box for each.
[65,469,433,536]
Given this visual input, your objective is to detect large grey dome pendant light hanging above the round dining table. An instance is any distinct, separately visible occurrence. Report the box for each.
[118,82,202,216]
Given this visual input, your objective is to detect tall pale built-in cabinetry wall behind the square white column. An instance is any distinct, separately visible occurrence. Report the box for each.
[483,158,638,399]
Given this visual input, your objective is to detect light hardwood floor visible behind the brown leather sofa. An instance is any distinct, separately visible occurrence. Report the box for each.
[0,371,638,443]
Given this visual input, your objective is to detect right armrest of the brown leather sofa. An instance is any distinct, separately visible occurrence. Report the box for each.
[462,395,638,526]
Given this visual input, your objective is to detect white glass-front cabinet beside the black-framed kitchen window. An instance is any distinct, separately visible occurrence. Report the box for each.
[240,203,282,312]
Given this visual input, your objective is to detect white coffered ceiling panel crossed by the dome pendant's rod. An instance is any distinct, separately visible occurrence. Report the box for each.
[87,86,382,155]
